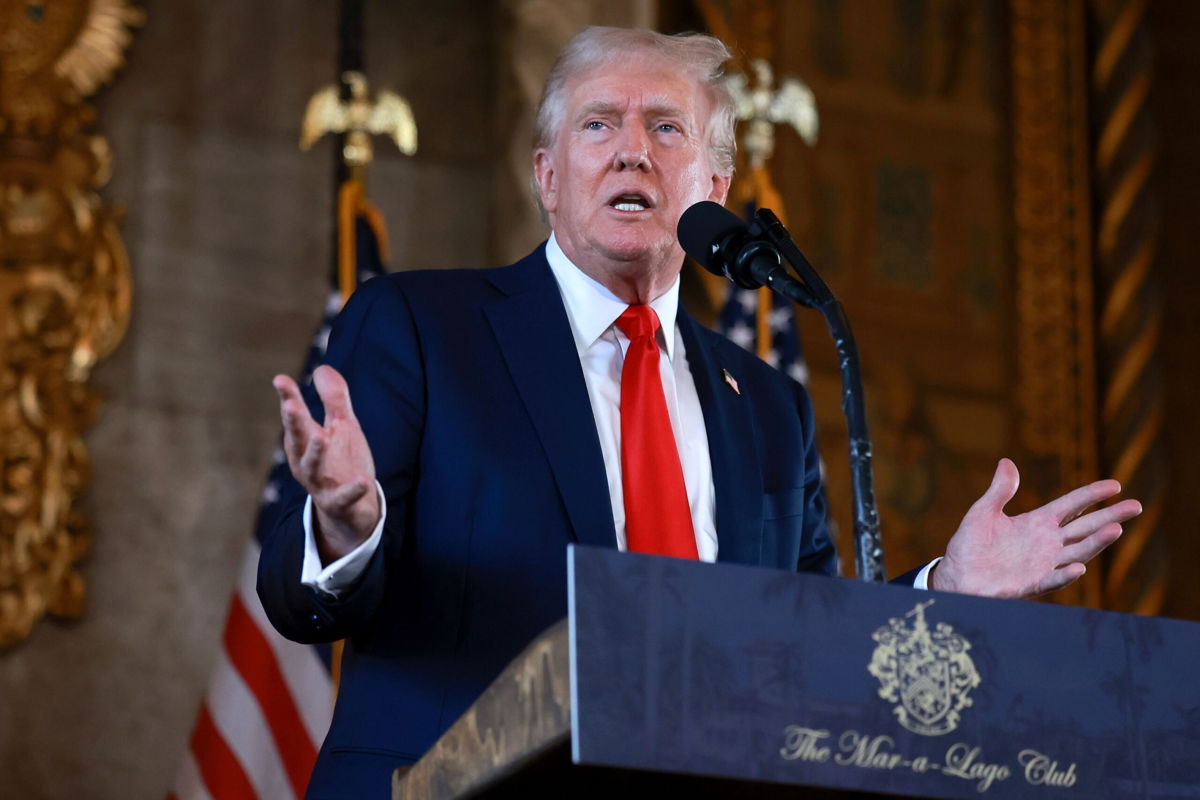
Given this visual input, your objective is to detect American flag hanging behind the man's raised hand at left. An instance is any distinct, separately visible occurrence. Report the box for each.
[168,212,385,800]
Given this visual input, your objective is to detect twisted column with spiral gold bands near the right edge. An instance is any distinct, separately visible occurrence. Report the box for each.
[1088,0,1168,614]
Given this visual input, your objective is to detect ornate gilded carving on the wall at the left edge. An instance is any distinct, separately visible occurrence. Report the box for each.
[0,0,143,646]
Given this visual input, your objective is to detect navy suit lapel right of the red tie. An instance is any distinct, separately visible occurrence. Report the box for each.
[679,308,762,564]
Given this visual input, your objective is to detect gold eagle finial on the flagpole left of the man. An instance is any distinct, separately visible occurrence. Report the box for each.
[300,72,416,168]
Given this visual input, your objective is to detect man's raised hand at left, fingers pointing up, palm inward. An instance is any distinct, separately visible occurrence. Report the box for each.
[272,366,380,564]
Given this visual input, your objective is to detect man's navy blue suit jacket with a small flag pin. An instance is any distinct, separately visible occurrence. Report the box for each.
[258,247,835,798]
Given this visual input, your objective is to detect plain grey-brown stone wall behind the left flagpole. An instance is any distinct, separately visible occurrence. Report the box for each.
[0,0,652,800]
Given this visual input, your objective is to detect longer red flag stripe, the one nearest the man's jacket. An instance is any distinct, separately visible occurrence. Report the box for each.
[224,594,317,796]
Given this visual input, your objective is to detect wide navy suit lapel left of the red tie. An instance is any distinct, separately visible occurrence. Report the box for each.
[484,248,617,547]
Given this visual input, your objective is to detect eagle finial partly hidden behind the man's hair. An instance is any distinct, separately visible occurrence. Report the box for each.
[725,59,818,168]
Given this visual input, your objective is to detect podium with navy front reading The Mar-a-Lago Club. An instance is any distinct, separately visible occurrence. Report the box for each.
[392,547,1200,800]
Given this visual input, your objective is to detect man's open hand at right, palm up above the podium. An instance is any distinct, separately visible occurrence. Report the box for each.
[930,458,1141,597]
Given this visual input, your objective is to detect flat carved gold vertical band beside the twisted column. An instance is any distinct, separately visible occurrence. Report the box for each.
[1009,0,1100,606]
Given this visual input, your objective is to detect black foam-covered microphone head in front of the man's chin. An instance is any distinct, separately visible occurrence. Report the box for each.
[676,200,791,289]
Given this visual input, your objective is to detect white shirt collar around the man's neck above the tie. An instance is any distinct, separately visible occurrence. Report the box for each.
[546,231,679,359]
